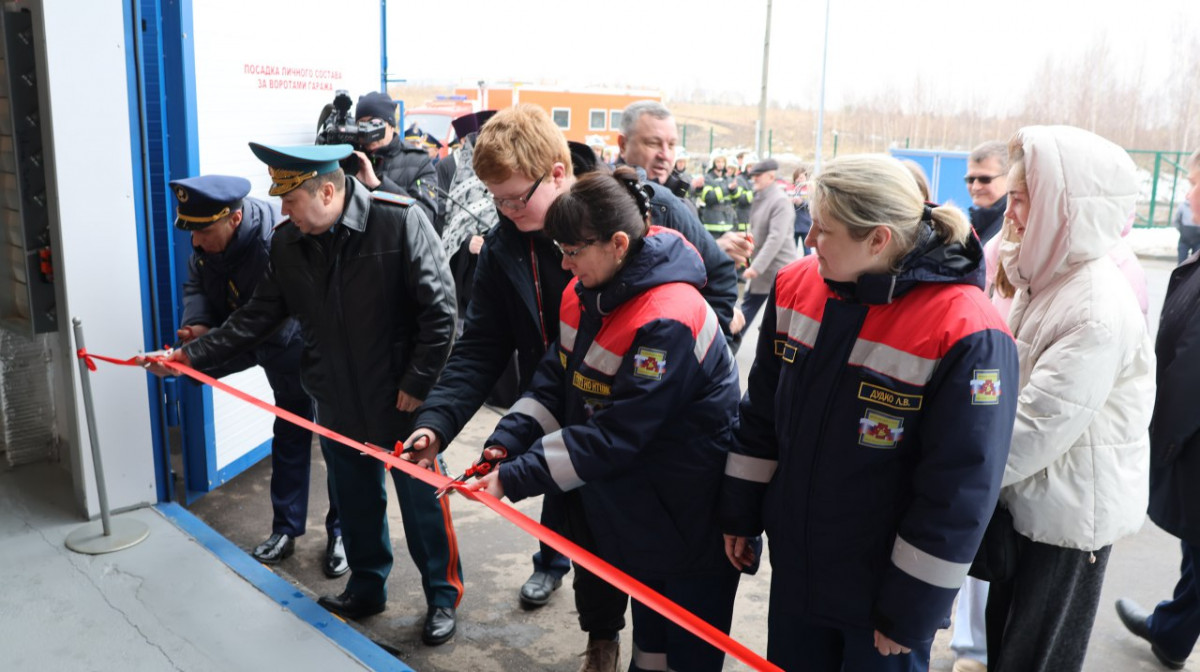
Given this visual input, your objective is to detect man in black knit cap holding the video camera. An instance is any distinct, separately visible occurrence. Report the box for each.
[354,91,438,222]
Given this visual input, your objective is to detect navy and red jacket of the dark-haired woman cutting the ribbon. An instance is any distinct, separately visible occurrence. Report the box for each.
[487,227,738,577]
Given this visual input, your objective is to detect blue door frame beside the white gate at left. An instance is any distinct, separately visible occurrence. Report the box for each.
[125,0,271,504]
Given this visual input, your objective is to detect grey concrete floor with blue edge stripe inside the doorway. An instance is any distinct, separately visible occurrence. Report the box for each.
[0,463,409,672]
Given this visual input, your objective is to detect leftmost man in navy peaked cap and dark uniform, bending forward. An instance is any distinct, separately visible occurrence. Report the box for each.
[170,175,349,578]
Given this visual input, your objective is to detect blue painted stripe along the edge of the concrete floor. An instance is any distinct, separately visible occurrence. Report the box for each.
[155,503,414,672]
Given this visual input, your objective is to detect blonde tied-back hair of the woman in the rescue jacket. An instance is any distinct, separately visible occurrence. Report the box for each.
[812,154,971,272]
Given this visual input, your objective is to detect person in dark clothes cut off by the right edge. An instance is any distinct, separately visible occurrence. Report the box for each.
[1117,150,1200,670]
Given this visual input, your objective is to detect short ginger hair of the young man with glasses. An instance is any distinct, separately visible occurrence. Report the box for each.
[473,103,571,182]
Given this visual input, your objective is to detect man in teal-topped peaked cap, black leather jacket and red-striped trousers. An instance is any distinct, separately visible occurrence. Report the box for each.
[148,143,463,646]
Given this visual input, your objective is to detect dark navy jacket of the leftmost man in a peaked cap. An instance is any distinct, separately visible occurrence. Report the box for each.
[179,198,300,369]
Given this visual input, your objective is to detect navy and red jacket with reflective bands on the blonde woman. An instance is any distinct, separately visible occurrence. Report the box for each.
[721,223,1019,648]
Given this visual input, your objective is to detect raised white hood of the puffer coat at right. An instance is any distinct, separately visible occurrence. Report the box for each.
[1006,126,1138,295]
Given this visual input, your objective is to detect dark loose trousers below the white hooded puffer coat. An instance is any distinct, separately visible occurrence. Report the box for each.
[986,536,1112,672]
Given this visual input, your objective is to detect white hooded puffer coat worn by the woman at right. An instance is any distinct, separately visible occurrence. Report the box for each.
[1001,126,1154,551]
